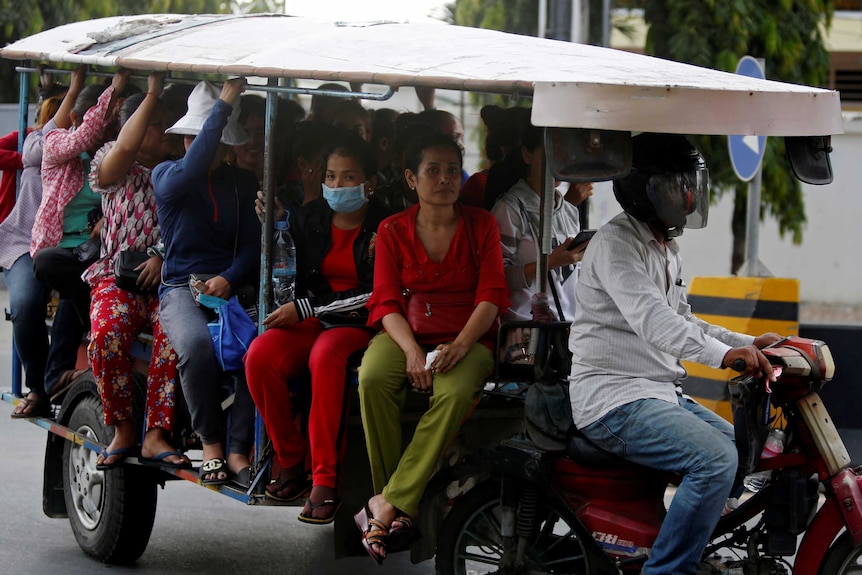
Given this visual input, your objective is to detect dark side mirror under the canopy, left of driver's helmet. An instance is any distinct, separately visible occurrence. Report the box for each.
[545,128,632,182]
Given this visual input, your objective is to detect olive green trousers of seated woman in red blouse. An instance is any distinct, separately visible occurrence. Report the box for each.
[359,332,494,515]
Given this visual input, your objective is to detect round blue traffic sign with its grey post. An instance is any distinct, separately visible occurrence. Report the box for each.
[727,56,772,277]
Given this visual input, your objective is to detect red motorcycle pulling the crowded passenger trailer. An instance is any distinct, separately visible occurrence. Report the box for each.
[437,337,862,575]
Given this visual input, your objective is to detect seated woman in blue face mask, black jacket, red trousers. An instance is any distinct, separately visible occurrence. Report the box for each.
[245,132,389,524]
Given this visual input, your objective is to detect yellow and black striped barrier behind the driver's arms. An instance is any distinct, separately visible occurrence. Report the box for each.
[682,277,799,421]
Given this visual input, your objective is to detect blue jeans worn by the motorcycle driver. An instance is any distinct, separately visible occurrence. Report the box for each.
[581,396,738,575]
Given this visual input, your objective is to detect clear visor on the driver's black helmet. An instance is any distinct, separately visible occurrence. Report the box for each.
[647,168,709,229]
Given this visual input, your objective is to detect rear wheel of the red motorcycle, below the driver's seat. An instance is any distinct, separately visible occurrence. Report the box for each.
[436,483,595,575]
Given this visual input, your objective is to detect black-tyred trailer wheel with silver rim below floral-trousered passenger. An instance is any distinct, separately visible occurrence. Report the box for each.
[63,380,157,564]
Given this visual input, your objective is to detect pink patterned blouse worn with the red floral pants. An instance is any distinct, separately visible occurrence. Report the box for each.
[81,142,161,286]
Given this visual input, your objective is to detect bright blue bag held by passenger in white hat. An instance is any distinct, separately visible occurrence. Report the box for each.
[198,294,257,371]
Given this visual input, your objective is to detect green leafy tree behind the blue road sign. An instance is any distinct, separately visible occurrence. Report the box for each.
[641,0,833,272]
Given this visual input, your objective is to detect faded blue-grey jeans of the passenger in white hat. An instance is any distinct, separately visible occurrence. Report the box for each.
[159,287,254,455]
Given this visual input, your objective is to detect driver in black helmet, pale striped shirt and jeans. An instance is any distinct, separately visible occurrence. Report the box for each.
[569,134,779,575]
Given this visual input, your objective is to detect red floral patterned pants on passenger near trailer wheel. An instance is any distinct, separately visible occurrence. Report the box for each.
[87,277,178,431]
